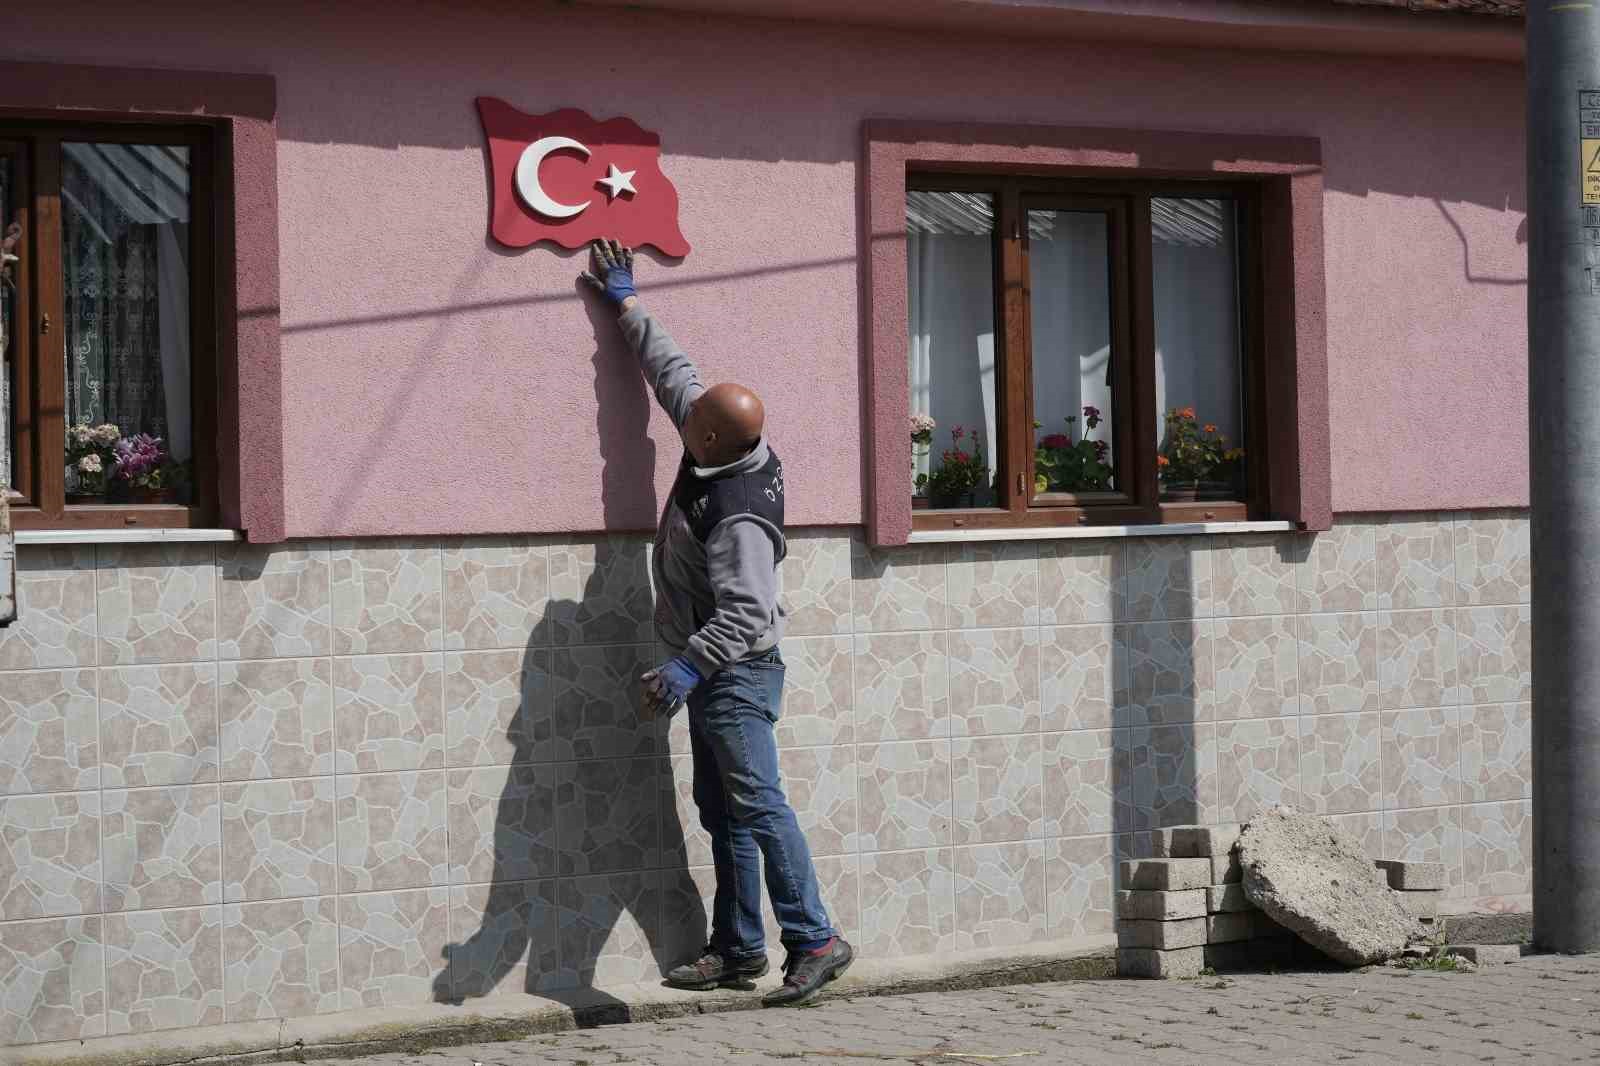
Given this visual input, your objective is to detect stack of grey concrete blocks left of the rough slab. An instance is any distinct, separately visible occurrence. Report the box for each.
[1117,826,1294,978]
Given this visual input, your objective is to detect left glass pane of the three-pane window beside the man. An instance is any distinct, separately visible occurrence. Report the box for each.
[906,190,998,507]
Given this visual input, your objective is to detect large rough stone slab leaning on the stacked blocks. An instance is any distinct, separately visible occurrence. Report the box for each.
[1238,807,1421,965]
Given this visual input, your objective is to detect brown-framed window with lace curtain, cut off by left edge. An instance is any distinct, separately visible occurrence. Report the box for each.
[0,122,218,528]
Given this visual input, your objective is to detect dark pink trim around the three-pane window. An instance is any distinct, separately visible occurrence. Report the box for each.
[862,120,1333,546]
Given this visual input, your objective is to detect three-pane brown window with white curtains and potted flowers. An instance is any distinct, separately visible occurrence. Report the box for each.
[906,171,1264,530]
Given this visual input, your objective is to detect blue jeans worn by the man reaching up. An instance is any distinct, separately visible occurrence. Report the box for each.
[688,648,834,959]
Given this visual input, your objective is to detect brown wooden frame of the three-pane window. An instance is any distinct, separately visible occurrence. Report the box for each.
[906,175,1270,541]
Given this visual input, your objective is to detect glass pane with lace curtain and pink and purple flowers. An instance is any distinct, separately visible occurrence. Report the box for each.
[61,142,192,503]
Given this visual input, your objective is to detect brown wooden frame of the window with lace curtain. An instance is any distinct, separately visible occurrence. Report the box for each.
[0,115,222,530]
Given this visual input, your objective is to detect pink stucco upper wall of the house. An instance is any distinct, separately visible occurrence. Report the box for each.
[0,0,1526,536]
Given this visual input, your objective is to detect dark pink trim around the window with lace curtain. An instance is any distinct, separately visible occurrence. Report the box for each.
[0,62,285,543]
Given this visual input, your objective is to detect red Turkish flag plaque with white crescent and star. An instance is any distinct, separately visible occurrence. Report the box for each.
[477,96,690,258]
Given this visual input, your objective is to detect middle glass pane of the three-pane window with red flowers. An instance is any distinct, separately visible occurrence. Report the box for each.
[1027,210,1115,495]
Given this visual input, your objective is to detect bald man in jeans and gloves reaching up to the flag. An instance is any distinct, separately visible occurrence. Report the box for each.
[584,240,853,1007]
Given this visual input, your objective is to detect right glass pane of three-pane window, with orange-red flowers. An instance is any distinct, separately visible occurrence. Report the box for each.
[1150,197,1246,499]
